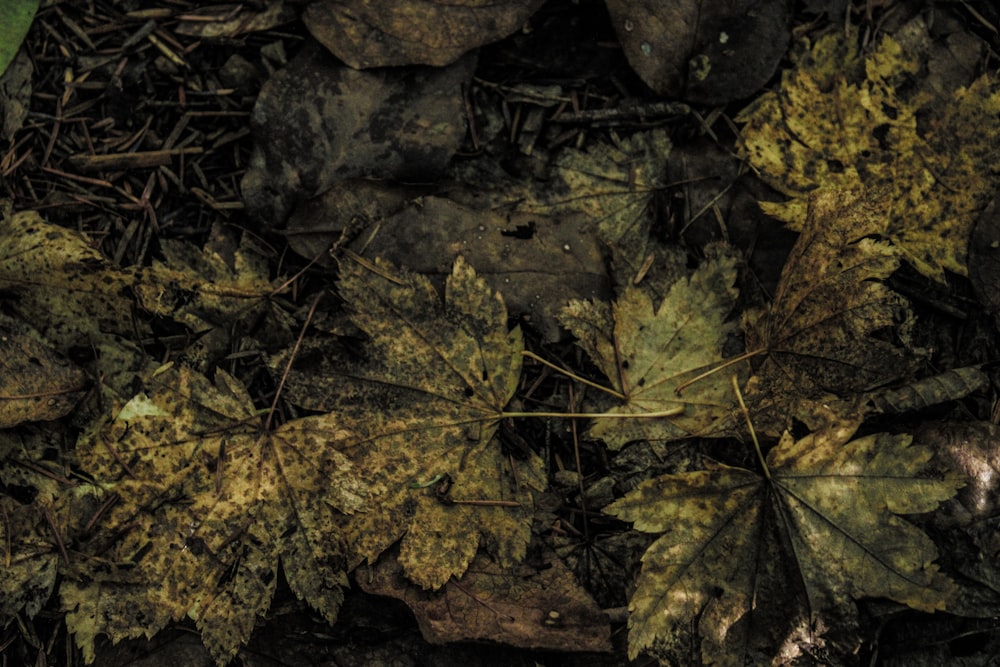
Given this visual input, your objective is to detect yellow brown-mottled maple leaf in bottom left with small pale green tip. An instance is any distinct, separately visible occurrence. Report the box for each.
[60,367,366,664]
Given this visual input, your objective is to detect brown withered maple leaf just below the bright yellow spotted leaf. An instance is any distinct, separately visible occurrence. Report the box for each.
[744,189,917,434]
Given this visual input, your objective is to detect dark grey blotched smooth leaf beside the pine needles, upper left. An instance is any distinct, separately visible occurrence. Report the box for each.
[241,44,475,226]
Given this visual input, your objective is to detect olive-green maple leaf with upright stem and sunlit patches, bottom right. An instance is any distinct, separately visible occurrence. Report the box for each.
[605,422,961,665]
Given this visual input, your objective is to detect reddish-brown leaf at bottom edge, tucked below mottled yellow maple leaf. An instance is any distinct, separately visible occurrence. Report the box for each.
[358,552,611,651]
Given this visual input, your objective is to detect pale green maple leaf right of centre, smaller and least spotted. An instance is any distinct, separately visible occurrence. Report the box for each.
[561,247,745,449]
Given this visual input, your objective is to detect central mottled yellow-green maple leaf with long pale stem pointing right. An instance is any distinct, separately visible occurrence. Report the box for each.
[288,257,545,588]
